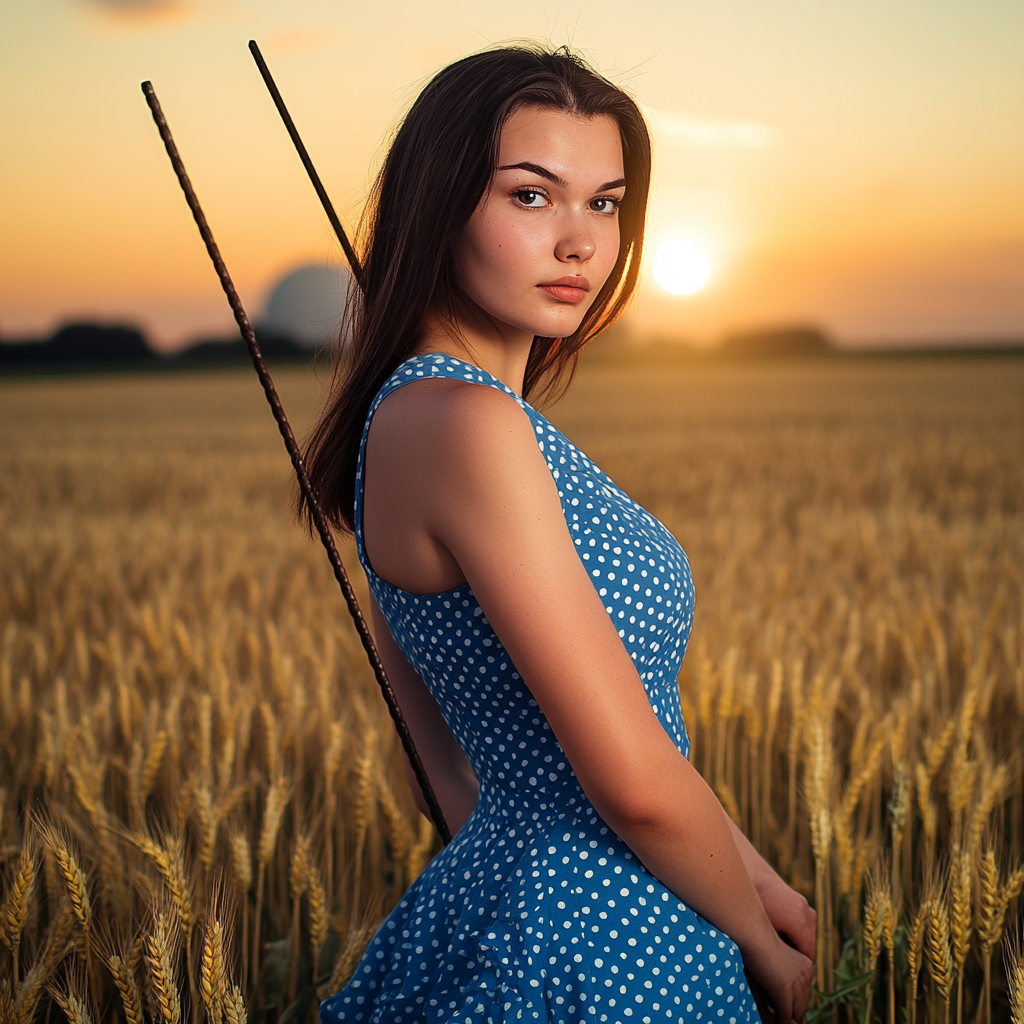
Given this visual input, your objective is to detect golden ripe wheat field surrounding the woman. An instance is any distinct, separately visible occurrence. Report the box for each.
[0,356,1024,1024]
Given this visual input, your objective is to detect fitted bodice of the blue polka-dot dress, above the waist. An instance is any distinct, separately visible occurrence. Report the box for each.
[355,354,693,801]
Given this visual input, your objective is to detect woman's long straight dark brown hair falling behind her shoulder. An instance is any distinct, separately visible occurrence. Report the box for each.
[299,44,650,531]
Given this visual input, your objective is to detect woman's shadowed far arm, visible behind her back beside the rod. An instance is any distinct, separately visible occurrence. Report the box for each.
[370,599,477,836]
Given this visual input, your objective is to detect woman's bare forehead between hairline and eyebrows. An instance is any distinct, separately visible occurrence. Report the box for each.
[498,106,623,181]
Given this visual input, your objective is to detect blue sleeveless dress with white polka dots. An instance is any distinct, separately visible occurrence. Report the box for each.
[319,354,760,1024]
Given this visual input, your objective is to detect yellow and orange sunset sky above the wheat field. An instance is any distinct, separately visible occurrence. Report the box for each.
[0,0,1024,348]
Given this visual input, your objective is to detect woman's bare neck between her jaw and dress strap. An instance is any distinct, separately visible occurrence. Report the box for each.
[414,303,534,395]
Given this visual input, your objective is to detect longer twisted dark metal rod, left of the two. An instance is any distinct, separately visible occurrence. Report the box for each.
[142,82,452,844]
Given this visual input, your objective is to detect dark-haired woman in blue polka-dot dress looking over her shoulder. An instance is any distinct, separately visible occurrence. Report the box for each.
[307,47,814,1022]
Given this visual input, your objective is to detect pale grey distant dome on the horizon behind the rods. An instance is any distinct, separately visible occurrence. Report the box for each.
[260,263,352,346]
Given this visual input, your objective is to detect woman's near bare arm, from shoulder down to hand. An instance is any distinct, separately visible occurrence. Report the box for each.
[364,381,813,1020]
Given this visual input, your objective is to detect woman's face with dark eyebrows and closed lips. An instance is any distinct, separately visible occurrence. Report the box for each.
[455,106,626,338]
